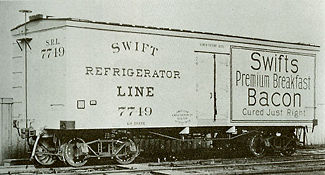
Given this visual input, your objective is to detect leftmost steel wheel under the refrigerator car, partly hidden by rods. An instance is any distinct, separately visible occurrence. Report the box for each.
[34,139,56,166]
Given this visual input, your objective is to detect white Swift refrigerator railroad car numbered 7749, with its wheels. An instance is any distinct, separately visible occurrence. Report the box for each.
[12,15,319,166]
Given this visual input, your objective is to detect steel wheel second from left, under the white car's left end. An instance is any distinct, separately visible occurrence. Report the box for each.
[63,138,88,167]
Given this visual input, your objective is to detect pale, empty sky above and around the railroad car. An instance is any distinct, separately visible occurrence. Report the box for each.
[0,0,325,143]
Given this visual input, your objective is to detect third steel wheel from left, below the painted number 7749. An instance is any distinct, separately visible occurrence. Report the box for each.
[115,139,139,165]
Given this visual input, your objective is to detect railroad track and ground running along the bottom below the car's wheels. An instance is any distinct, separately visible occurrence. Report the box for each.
[0,151,325,175]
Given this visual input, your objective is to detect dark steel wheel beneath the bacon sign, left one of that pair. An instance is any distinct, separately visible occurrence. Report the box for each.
[248,134,266,157]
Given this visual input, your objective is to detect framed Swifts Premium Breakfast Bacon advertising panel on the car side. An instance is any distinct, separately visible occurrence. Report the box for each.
[231,46,315,122]
